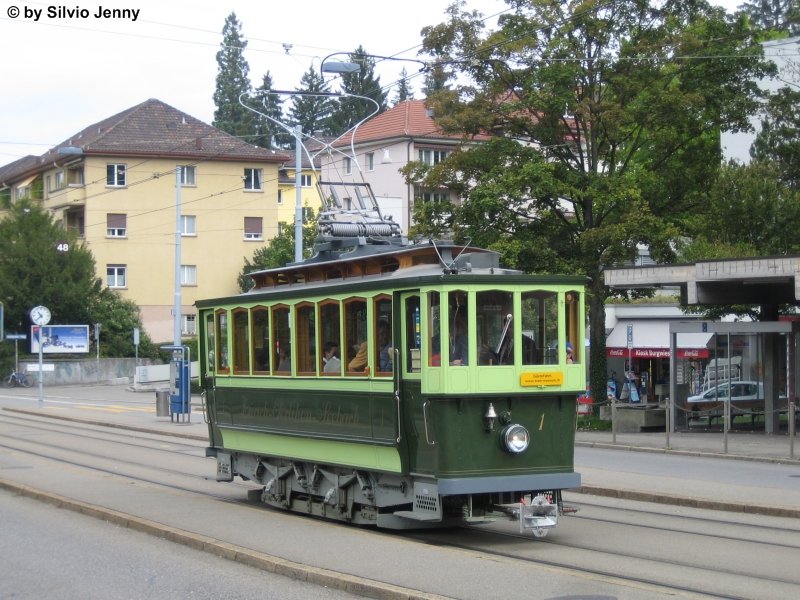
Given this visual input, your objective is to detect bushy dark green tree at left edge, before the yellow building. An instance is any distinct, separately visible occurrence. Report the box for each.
[0,201,155,366]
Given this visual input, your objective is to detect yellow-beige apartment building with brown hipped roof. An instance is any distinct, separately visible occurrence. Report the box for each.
[0,99,294,342]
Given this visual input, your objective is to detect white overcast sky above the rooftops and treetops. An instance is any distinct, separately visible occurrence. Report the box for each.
[0,0,741,165]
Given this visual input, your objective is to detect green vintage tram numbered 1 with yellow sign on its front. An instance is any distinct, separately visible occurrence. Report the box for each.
[197,179,586,535]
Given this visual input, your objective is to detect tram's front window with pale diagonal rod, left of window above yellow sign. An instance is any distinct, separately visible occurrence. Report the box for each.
[475,290,514,365]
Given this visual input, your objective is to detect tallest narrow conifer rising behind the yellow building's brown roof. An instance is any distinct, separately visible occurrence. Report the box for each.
[212,12,256,138]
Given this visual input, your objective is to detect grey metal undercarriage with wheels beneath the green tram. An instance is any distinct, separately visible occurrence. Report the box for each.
[209,449,564,537]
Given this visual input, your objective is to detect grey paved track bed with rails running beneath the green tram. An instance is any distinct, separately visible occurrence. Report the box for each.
[0,406,800,598]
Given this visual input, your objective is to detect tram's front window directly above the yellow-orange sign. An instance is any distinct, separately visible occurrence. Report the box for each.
[522,290,558,365]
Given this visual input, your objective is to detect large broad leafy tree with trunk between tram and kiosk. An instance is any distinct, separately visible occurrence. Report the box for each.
[416,0,769,406]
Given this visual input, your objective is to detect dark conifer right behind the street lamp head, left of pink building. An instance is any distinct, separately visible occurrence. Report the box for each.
[327,46,387,135]
